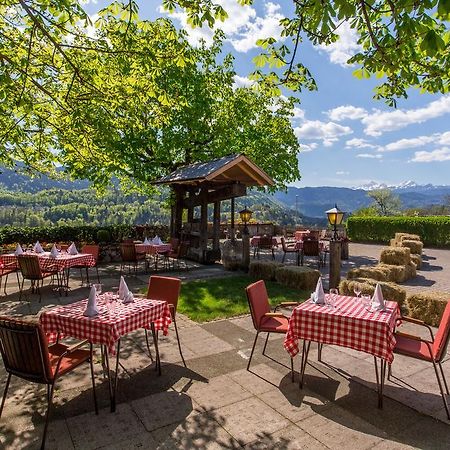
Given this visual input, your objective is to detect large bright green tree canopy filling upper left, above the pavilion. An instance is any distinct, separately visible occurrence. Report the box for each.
[0,0,300,190]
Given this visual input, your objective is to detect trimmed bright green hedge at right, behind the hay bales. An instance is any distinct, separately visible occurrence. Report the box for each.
[347,216,450,247]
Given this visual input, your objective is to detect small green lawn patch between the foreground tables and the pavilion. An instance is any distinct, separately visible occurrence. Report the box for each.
[178,275,309,322]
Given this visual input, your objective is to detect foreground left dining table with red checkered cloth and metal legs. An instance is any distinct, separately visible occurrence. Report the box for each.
[39,292,172,412]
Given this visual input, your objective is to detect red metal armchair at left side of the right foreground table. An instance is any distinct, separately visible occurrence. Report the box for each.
[245,280,298,380]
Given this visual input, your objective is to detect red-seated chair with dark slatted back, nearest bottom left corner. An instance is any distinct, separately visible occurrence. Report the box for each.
[0,317,98,449]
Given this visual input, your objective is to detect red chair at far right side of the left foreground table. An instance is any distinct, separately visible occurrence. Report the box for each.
[145,275,187,371]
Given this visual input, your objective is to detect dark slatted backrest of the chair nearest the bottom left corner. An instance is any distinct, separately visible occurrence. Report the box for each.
[0,316,53,384]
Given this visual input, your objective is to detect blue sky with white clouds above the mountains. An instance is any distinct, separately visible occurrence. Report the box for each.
[82,0,450,187]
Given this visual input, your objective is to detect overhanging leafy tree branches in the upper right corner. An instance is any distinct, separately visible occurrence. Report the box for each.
[169,0,450,106]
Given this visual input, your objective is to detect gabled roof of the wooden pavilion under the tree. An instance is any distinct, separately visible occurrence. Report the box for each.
[154,154,274,186]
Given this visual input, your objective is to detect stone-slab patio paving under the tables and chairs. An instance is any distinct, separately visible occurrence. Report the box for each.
[0,244,450,449]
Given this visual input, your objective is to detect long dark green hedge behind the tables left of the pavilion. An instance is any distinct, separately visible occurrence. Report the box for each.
[0,225,169,245]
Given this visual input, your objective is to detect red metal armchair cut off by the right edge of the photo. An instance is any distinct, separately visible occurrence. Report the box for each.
[388,301,450,420]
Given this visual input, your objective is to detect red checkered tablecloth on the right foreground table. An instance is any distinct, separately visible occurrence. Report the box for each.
[284,296,400,363]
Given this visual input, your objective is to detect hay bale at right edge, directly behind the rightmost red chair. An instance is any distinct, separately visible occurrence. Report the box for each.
[407,291,450,327]
